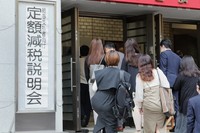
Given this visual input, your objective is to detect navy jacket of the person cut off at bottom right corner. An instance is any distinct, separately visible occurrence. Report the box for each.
[187,95,200,133]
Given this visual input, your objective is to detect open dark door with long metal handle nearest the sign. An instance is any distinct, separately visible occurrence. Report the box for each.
[62,8,81,131]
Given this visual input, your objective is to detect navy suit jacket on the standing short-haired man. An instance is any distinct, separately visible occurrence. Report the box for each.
[159,50,181,88]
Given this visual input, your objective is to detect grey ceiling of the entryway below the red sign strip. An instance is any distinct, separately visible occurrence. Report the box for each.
[61,0,200,21]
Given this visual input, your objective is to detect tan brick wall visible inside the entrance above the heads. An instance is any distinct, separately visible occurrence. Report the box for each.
[79,17,123,44]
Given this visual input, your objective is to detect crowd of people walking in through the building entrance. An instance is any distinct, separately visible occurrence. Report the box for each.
[80,38,200,133]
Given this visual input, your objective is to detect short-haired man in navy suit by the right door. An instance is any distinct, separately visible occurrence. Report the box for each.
[159,39,181,132]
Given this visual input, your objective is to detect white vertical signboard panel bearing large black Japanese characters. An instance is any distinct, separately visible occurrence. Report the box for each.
[18,2,55,112]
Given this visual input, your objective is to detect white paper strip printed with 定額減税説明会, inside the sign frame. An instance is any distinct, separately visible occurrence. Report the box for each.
[25,6,49,108]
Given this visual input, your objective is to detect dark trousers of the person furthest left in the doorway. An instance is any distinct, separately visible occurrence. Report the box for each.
[80,83,92,126]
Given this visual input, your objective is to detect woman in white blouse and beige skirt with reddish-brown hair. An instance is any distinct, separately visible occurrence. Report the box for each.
[135,55,169,133]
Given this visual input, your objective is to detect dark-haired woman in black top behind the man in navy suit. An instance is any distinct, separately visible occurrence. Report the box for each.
[174,55,200,133]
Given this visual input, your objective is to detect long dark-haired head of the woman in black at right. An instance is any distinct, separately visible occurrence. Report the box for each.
[180,55,200,77]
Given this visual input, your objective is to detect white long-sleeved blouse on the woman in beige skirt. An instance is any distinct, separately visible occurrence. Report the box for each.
[134,68,170,108]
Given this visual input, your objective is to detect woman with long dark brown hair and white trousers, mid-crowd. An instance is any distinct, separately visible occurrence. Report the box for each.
[121,38,143,133]
